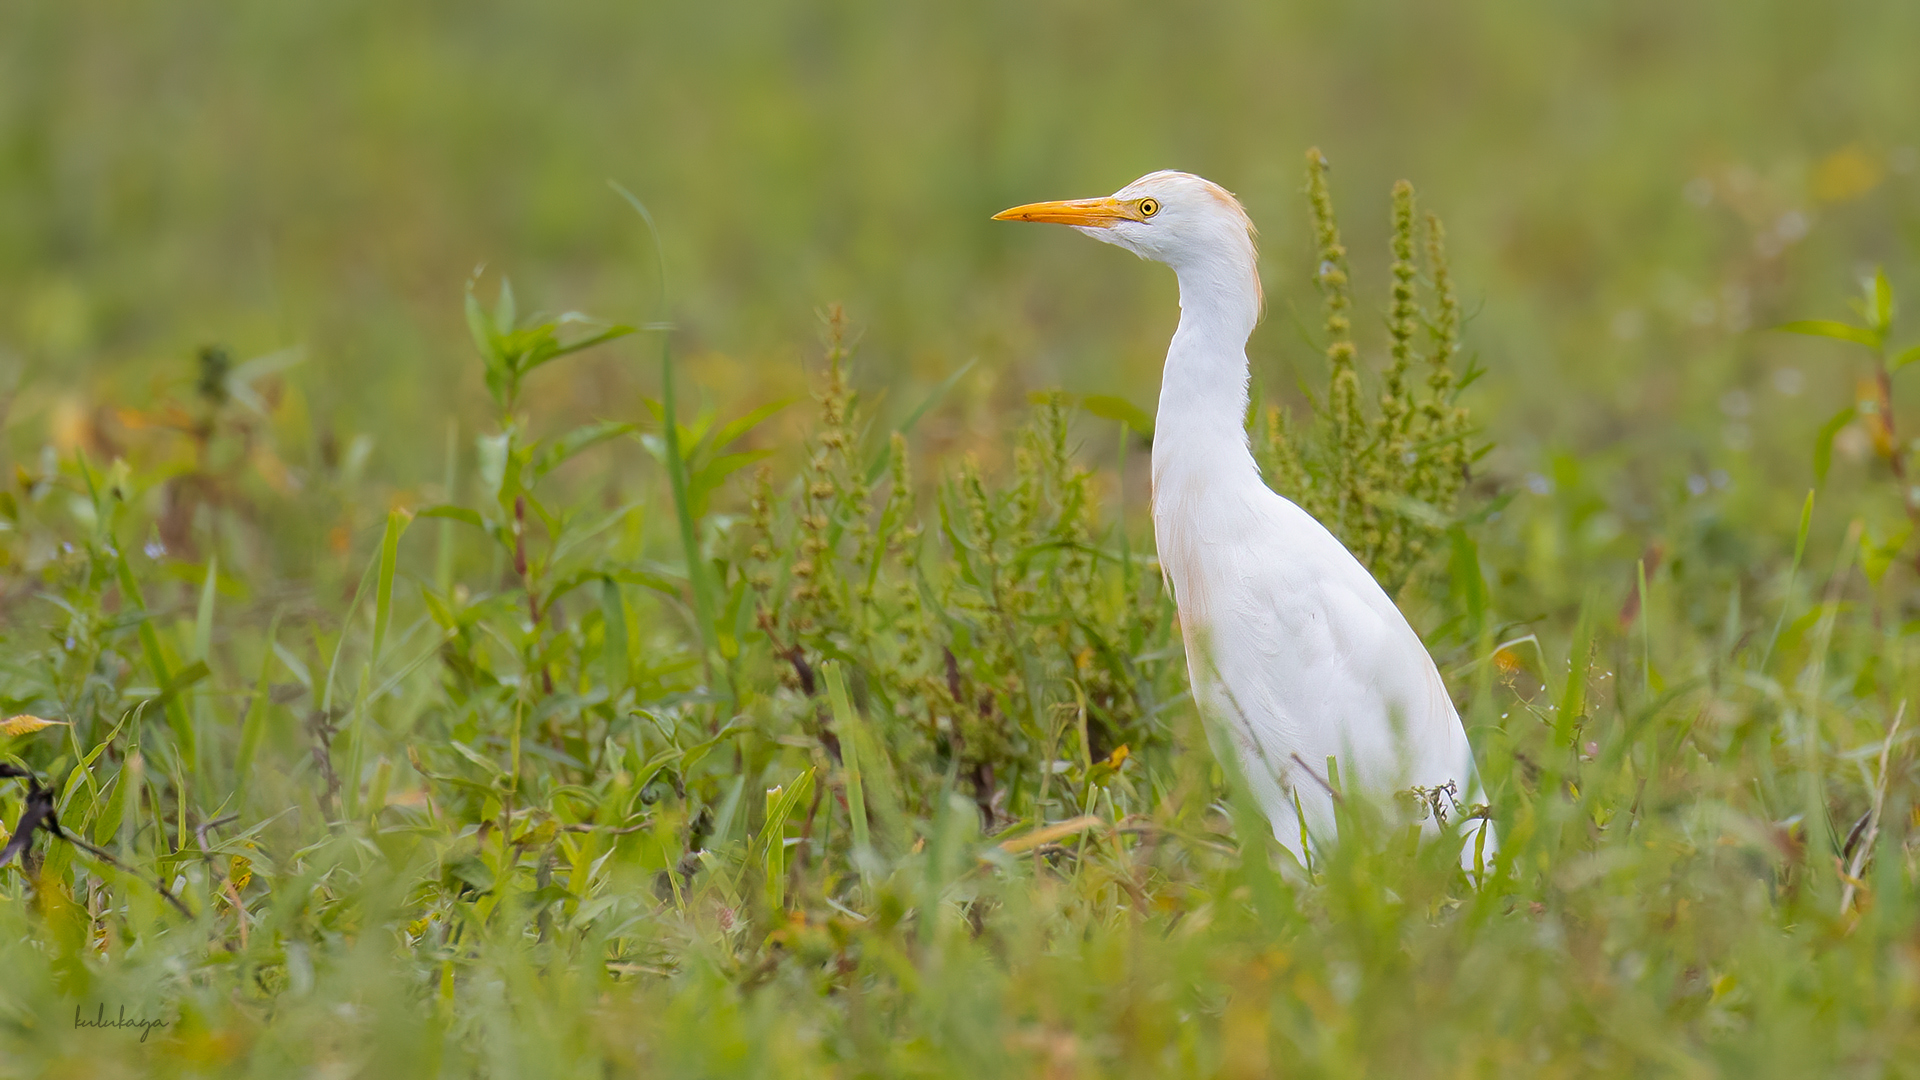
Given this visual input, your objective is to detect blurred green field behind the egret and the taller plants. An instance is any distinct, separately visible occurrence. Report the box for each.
[0,0,1920,528]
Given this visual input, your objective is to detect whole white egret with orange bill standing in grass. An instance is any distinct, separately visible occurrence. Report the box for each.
[995,171,1492,867]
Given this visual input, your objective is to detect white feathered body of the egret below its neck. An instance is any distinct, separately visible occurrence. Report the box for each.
[1156,474,1473,855]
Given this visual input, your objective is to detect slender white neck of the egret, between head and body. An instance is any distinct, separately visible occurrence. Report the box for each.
[1154,252,1261,499]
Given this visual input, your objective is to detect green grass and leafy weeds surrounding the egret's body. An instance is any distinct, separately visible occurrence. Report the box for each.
[0,171,1920,1078]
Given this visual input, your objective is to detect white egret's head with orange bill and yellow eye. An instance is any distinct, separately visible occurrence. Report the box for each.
[993,171,1260,303]
